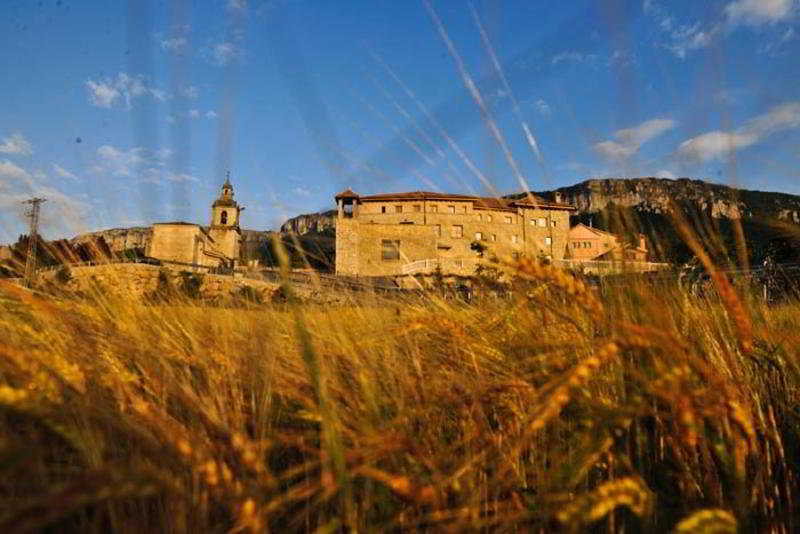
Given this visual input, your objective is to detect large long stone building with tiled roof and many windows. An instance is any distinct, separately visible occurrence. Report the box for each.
[335,189,574,276]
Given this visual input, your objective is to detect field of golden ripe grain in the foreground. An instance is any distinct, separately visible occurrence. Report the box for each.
[0,262,800,532]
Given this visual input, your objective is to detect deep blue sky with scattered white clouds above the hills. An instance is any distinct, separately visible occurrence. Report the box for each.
[0,0,800,243]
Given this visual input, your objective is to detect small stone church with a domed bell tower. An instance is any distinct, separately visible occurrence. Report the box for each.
[146,173,244,269]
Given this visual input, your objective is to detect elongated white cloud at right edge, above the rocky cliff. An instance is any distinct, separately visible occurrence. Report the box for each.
[678,102,800,161]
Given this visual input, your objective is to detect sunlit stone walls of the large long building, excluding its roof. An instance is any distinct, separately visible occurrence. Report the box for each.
[336,205,569,276]
